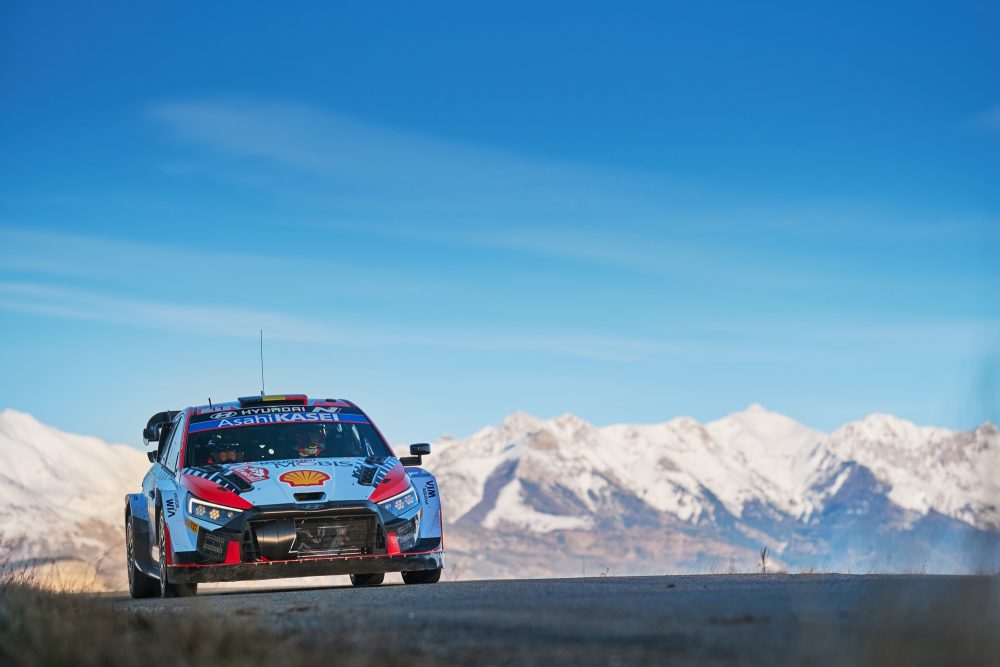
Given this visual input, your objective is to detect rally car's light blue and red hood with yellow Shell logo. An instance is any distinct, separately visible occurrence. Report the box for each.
[180,457,409,509]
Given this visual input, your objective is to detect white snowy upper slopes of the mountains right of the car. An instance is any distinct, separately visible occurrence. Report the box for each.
[430,405,1000,531]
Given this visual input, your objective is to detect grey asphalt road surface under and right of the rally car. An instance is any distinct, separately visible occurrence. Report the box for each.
[110,575,1000,666]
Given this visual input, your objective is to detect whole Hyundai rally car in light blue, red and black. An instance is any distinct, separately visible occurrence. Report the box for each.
[125,395,444,597]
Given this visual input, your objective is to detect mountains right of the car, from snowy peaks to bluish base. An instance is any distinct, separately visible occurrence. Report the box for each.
[428,405,1000,571]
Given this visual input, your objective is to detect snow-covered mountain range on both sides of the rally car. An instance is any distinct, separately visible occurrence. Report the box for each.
[0,405,1000,586]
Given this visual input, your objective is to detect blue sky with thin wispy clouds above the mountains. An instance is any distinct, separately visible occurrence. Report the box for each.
[0,2,1000,443]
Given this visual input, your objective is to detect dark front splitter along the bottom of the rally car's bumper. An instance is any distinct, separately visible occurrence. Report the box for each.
[167,551,444,584]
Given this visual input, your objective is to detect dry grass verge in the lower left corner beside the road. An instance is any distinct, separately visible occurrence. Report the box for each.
[0,564,403,667]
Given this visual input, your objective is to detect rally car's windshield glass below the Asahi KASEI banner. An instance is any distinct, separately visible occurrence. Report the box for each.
[184,422,392,467]
